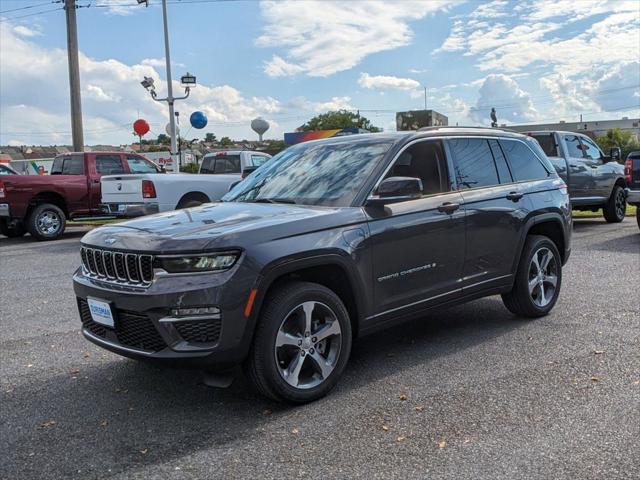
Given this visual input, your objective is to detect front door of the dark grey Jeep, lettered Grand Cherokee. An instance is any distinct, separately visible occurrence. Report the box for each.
[365,140,465,315]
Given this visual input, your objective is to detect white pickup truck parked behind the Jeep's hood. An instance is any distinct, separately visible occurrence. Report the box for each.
[100,150,271,218]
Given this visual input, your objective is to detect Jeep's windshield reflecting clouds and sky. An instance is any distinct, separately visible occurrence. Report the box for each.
[222,138,392,207]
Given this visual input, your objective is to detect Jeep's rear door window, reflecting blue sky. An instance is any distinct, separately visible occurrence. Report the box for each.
[449,138,500,190]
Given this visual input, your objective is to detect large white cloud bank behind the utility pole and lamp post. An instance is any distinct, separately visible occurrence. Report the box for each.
[0,22,281,144]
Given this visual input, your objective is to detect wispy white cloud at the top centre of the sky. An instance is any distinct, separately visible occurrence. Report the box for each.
[256,0,459,77]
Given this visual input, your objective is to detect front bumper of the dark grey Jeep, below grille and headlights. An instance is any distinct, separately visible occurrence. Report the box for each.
[73,267,253,370]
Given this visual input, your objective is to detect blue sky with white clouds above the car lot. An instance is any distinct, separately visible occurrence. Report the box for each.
[0,0,640,144]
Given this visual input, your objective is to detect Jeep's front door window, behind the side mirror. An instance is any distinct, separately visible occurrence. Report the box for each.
[385,140,450,195]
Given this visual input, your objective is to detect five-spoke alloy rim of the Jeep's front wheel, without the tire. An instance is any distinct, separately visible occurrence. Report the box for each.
[274,301,342,389]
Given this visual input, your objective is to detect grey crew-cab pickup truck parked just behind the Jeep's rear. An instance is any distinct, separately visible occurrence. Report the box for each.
[527,131,627,222]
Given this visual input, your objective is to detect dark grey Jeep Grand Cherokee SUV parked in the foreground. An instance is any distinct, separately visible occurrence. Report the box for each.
[74,128,571,403]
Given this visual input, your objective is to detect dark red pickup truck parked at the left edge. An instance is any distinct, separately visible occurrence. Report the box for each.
[0,152,164,240]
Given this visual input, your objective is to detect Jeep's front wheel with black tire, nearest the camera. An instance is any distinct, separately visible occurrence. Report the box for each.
[245,282,351,404]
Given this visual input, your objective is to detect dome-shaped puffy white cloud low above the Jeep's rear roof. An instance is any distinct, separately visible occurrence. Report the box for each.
[469,74,538,124]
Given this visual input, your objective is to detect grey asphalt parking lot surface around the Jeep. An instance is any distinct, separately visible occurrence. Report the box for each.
[0,218,640,479]
